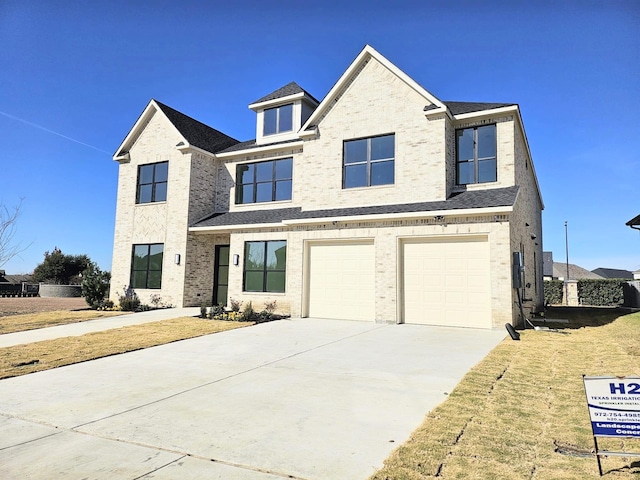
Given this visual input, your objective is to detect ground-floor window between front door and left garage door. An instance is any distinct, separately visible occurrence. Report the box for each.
[242,240,287,292]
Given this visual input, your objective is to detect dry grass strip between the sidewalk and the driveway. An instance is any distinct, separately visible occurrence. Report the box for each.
[0,317,253,380]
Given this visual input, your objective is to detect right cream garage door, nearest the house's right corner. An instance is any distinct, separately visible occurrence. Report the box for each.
[403,237,492,328]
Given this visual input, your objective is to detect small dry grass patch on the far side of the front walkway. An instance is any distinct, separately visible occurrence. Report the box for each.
[0,310,123,335]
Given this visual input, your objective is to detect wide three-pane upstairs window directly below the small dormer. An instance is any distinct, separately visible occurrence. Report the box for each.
[236,158,293,203]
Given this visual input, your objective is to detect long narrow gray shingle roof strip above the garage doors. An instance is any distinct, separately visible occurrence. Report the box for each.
[191,186,519,227]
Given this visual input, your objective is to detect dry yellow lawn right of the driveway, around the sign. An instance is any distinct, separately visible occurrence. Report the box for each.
[371,310,640,480]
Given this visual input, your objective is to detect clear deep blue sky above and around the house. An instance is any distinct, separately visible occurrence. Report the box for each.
[0,0,640,273]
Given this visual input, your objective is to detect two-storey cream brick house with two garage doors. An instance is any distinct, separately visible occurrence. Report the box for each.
[111,46,543,328]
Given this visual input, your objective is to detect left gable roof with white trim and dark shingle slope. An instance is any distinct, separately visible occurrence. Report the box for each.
[113,99,238,161]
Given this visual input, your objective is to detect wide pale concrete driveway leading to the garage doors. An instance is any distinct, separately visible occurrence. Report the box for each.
[0,319,505,480]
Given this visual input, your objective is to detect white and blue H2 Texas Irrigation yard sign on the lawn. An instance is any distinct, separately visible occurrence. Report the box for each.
[582,375,640,476]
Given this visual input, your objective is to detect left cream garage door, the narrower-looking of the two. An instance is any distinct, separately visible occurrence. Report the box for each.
[307,242,375,321]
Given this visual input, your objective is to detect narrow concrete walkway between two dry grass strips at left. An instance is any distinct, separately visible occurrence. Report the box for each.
[0,307,200,348]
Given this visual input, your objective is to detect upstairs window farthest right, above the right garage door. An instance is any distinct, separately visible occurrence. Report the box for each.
[456,125,498,185]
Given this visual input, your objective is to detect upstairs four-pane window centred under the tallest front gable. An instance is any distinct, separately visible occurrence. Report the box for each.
[342,135,395,188]
